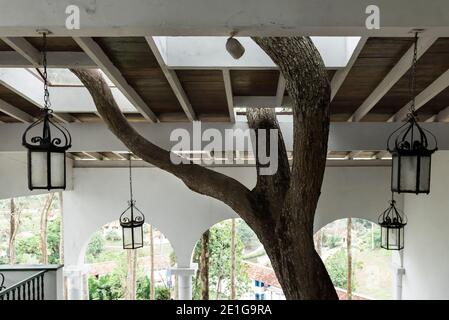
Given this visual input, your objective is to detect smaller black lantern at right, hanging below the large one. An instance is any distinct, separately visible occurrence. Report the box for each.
[378,199,407,250]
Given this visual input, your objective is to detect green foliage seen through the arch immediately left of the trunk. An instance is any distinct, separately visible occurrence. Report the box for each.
[193,220,250,299]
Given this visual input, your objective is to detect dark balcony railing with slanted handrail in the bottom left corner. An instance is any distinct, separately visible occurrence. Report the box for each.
[0,270,47,300]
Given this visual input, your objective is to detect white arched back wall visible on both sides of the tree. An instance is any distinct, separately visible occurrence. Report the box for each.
[64,167,389,267]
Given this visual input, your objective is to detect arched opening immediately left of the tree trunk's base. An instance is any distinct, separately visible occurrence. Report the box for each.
[192,218,284,300]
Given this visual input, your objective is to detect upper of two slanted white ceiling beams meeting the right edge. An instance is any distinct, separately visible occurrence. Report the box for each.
[388,69,449,122]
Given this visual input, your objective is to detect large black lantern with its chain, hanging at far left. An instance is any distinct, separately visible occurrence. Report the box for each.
[22,33,72,190]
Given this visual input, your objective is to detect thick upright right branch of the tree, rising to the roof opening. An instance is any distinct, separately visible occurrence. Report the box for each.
[253,37,330,234]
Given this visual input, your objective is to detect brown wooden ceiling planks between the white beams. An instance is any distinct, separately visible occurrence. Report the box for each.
[0,37,449,122]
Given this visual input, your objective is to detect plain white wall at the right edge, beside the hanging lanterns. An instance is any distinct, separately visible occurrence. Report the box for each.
[403,151,449,299]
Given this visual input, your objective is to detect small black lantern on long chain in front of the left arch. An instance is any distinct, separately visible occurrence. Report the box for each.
[120,155,145,249]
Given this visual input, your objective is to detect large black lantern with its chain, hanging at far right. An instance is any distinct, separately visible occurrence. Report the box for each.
[387,35,438,194]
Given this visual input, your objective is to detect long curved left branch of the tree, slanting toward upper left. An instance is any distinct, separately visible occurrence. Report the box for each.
[71,69,254,228]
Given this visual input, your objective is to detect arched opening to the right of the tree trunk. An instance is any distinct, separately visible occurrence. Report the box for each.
[314,218,393,300]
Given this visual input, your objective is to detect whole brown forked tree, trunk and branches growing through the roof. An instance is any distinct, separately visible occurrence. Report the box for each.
[72,37,337,299]
